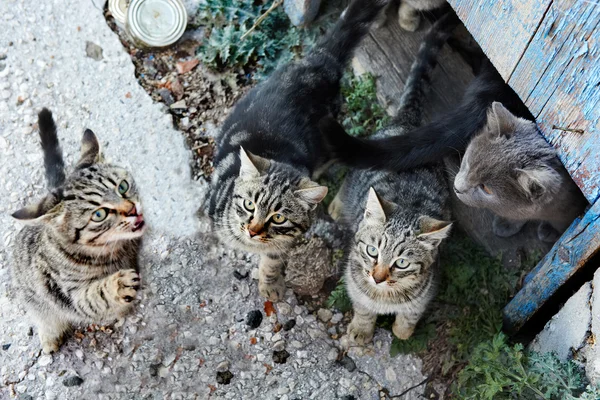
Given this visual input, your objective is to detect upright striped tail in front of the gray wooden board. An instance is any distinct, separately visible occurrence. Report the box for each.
[392,12,460,129]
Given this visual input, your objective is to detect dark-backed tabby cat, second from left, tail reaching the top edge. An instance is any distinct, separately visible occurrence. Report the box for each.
[208,0,387,301]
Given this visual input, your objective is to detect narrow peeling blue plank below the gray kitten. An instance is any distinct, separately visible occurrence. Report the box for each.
[504,202,600,333]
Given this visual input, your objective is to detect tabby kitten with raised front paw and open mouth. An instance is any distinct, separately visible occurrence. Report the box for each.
[12,108,145,353]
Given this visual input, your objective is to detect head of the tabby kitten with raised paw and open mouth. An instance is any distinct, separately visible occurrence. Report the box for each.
[13,131,145,248]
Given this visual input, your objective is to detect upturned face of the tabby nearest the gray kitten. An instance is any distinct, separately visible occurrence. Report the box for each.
[348,189,451,299]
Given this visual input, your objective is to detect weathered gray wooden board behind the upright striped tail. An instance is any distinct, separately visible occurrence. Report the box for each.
[353,13,473,120]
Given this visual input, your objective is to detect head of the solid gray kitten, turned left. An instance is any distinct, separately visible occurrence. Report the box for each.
[454,103,560,219]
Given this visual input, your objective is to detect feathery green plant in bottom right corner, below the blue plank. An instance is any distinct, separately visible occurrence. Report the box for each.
[452,333,600,400]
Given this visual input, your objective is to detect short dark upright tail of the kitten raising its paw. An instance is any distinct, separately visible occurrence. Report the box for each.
[38,108,65,188]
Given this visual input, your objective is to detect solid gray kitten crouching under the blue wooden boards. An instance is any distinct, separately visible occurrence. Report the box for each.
[454,102,588,242]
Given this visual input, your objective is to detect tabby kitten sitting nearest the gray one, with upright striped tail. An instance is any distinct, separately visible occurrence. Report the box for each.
[321,15,458,345]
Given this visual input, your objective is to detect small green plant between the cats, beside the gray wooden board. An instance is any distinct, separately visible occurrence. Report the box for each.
[341,73,390,136]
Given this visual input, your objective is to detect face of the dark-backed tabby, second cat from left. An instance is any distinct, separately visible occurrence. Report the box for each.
[225,149,327,253]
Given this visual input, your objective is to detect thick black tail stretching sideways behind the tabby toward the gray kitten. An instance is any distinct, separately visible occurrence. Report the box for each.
[319,47,533,171]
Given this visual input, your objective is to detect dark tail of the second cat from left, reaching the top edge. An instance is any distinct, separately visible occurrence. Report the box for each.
[312,0,390,68]
